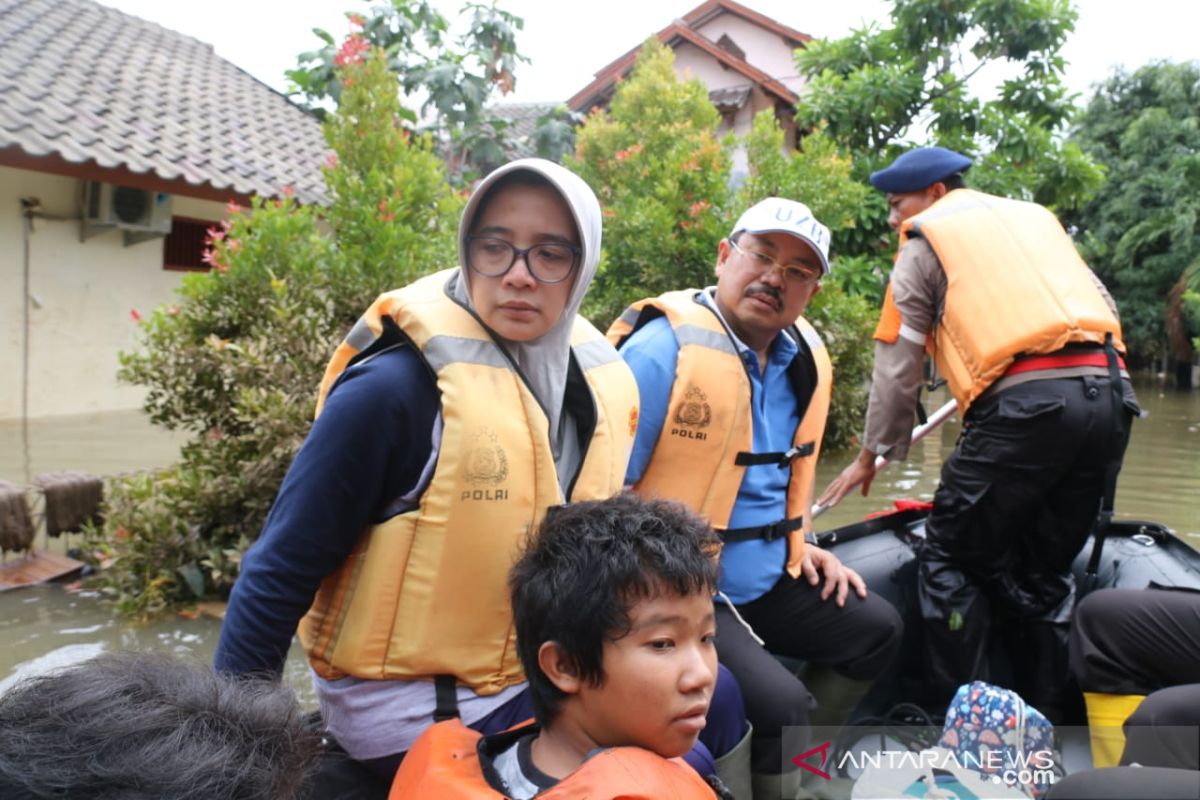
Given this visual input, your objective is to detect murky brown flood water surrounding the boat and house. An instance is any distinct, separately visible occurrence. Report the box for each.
[0,381,1200,704]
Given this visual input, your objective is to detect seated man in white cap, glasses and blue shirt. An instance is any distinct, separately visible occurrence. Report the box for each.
[608,198,901,798]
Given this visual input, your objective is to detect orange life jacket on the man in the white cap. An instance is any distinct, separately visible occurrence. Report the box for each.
[608,289,833,563]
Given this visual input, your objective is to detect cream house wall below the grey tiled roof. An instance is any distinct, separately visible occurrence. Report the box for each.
[0,167,224,420]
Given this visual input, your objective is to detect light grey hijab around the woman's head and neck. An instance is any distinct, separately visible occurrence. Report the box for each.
[446,158,601,494]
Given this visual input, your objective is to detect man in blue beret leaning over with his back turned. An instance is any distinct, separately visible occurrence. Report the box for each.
[820,148,1138,720]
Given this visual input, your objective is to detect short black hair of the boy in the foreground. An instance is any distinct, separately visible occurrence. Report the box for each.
[509,492,719,724]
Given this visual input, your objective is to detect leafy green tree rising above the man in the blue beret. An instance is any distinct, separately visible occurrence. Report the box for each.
[796,0,1103,269]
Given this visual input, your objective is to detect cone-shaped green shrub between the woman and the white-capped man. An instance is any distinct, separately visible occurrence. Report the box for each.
[568,38,732,329]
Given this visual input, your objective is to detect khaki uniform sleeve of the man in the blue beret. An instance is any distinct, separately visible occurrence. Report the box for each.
[863,239,946,461]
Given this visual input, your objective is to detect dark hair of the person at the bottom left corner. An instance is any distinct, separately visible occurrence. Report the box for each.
[0,652,320,800]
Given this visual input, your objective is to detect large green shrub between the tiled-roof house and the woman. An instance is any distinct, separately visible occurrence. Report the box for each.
[90,35,461,615]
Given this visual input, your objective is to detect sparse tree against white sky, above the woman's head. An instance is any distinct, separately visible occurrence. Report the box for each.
[288,0,527,182]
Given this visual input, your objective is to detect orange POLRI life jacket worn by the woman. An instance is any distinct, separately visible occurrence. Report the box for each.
[299,272,637,694]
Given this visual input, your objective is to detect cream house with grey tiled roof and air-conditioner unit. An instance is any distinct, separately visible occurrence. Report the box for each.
[0,0,326,421]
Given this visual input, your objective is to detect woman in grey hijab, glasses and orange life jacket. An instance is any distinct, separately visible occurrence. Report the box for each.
[215,158,740,776]
